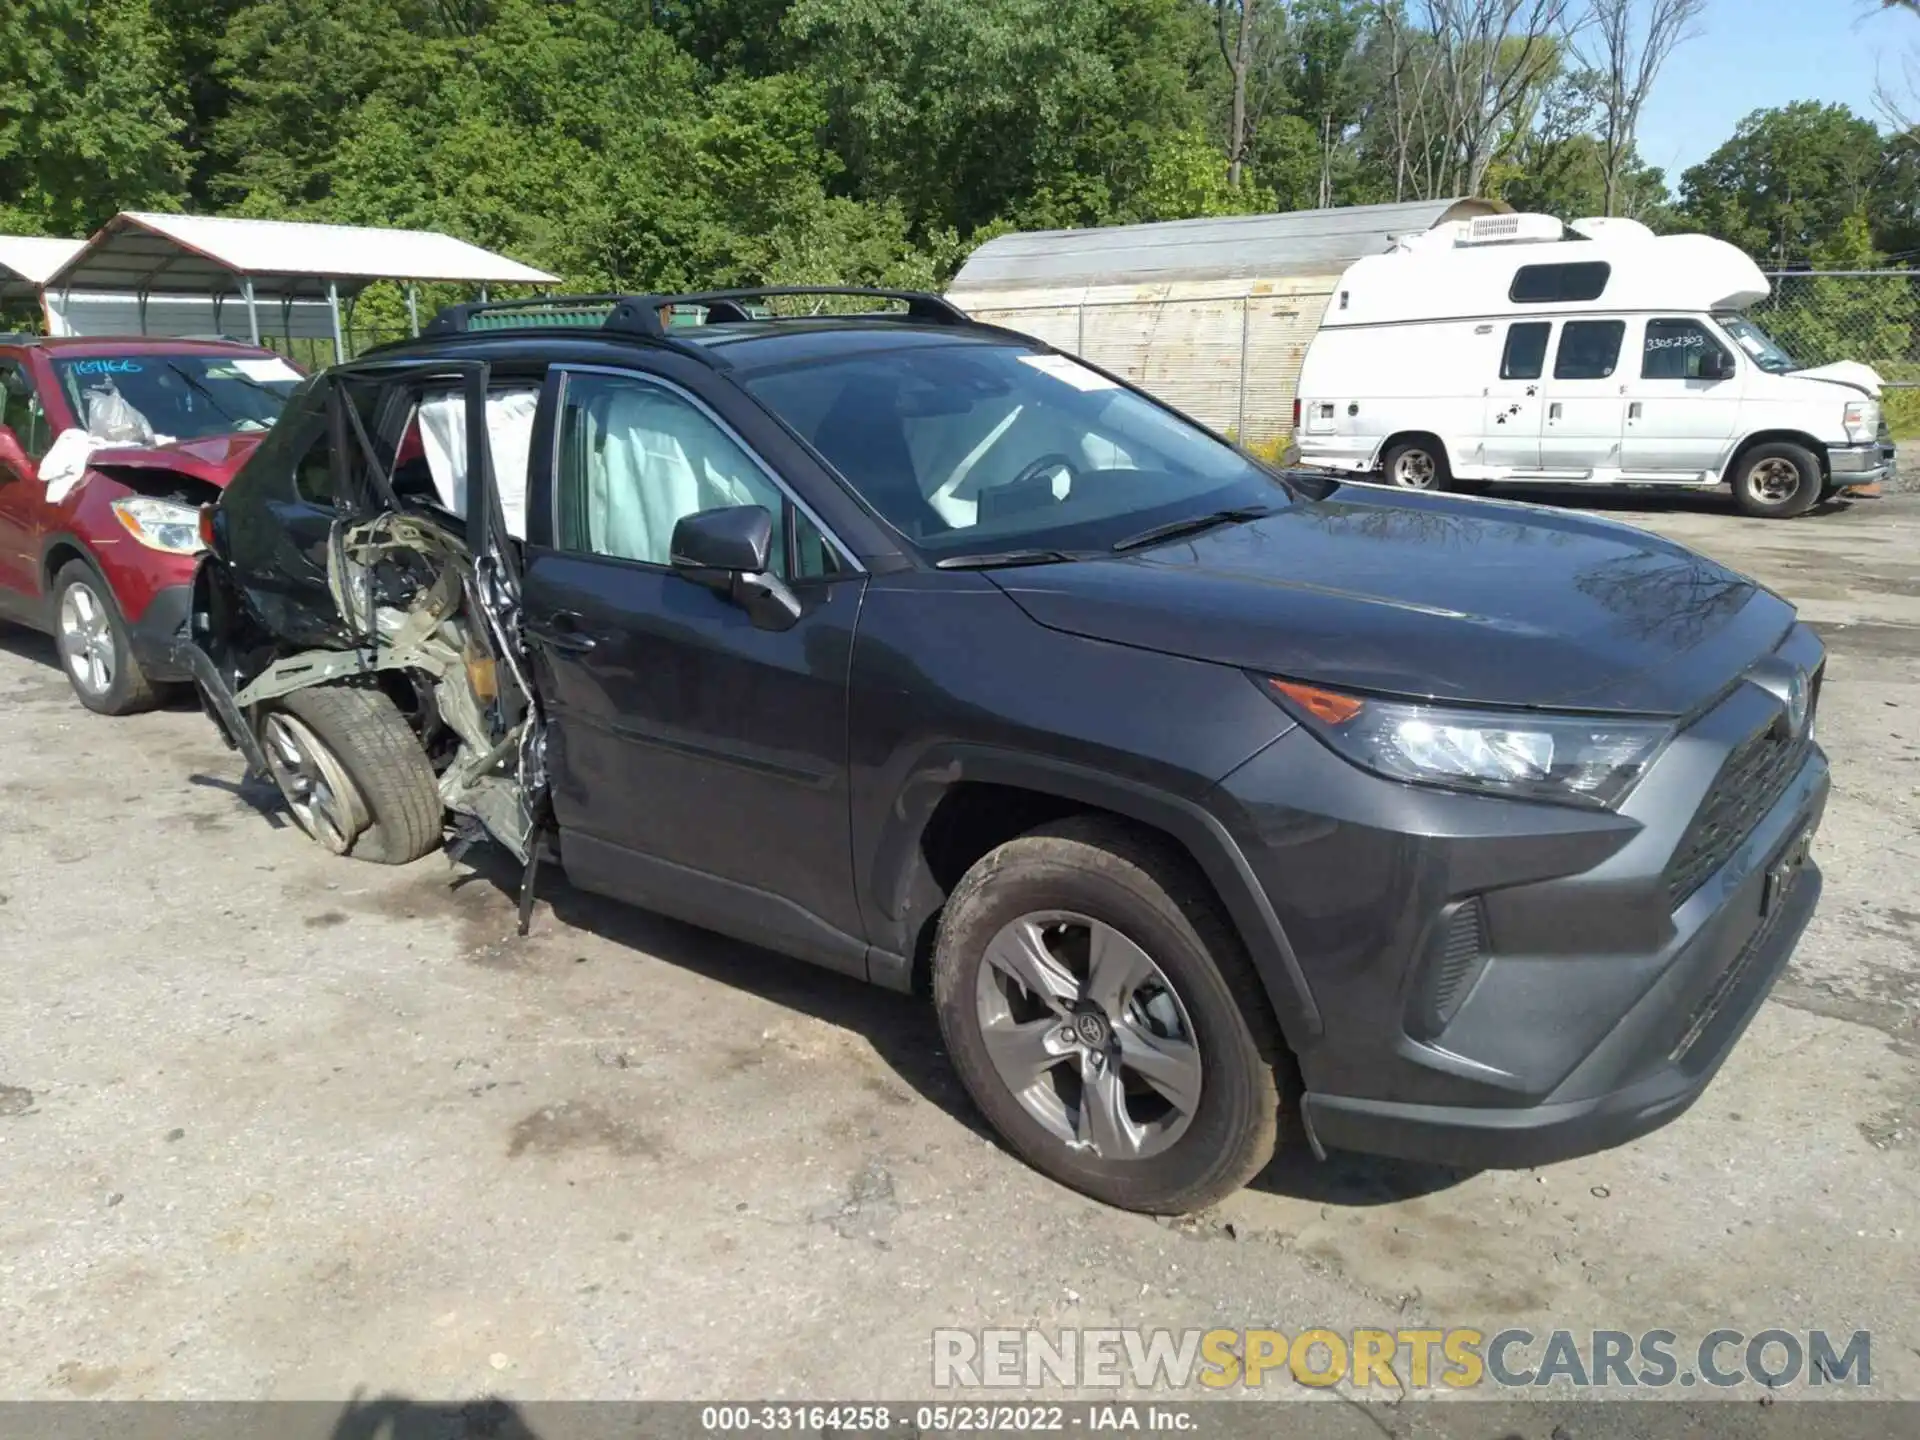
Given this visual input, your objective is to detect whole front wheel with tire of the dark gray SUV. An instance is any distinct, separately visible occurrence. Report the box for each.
[933,816,1281,1213]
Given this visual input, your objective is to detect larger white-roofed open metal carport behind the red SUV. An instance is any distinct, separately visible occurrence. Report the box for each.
[46,209,559,359]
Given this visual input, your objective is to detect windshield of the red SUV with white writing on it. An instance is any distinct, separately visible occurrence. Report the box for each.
[54,351,300,445]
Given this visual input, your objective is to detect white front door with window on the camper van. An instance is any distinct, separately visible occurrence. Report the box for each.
[1620,317,1741,480]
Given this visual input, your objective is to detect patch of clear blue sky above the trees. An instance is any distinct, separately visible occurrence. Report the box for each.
[1638,0,1920,190]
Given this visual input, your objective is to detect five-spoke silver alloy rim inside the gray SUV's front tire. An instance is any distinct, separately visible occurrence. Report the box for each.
[975,910,1202,1160]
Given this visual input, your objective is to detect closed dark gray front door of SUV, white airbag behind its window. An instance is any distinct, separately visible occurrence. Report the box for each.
[524,371,866,975]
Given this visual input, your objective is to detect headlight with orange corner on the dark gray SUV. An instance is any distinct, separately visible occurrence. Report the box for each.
[1265,680,1672,806]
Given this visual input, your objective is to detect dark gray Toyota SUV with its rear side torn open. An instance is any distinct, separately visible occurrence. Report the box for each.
[186,290,1828,1212]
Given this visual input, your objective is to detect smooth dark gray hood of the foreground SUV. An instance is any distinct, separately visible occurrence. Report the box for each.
[989,484,1793,714]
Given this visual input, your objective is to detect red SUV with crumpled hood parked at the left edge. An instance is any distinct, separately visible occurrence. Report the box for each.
[0,336,301,714]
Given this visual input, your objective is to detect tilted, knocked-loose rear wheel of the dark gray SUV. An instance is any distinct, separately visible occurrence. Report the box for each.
[259,685,444,866]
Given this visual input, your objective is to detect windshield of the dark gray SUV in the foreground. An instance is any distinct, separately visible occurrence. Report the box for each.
[745,344,1288,559]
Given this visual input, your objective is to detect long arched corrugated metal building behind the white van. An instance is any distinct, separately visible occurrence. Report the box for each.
[948,200,1507,445]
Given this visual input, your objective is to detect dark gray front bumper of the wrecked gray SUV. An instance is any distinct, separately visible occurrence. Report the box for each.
[1217,628,1830,1167]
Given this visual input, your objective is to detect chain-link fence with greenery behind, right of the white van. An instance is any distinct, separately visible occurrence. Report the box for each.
[1747,271,1920,440]
